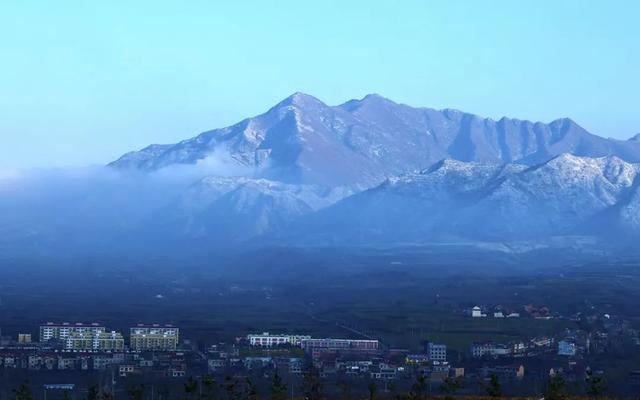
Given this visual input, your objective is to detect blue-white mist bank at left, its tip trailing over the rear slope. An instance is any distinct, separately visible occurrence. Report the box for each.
[0,152,254,255]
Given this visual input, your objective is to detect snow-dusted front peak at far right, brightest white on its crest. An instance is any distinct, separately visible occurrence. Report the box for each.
[461,154,638,238]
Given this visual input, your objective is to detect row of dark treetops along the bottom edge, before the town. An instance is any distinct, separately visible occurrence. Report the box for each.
[6,367,606,400]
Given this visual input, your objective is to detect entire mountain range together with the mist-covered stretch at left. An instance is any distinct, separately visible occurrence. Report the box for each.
[0,93,640,251]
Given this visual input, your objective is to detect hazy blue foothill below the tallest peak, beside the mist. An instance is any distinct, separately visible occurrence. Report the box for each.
[140,176,353,242]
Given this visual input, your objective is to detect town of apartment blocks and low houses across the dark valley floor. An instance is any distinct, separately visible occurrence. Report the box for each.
[0,306,640,398]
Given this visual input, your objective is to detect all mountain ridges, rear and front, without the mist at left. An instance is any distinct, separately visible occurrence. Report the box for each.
[110,93,640,244]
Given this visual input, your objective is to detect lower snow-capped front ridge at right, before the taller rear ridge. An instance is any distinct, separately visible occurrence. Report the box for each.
[282,154,640,243]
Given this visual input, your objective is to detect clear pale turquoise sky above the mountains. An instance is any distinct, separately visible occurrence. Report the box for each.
[0,0,640,168]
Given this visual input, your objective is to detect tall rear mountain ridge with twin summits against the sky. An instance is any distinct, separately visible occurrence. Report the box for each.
[110,93,640,185]
